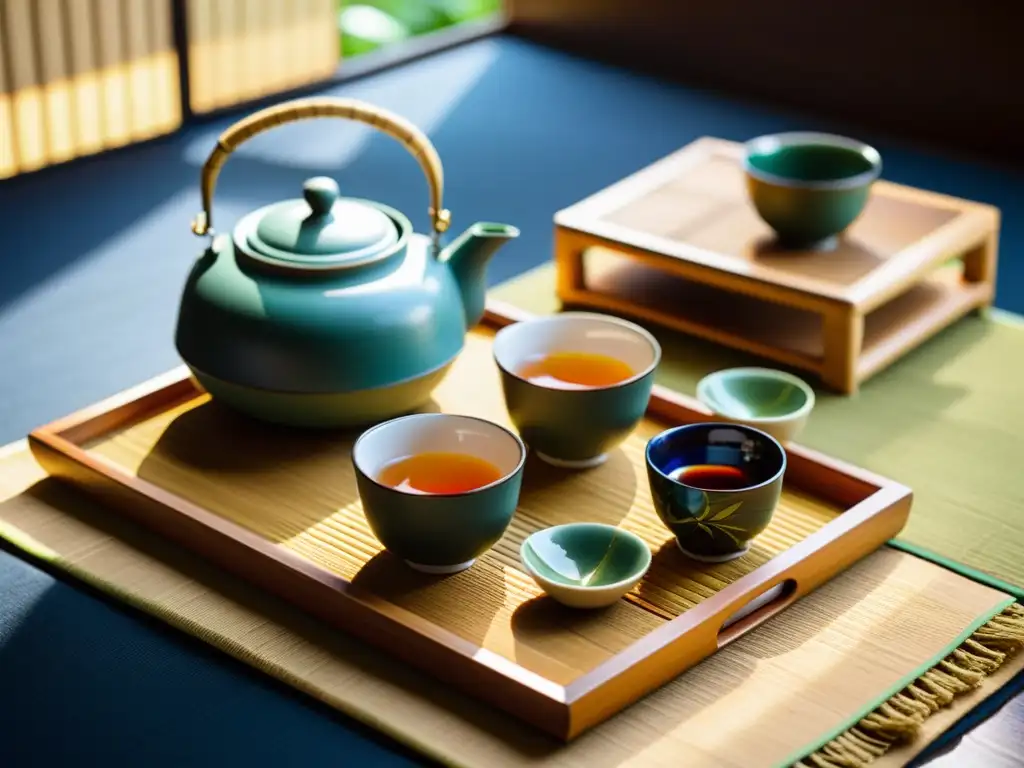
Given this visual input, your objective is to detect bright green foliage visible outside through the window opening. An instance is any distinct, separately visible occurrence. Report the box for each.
[338,0,502,56]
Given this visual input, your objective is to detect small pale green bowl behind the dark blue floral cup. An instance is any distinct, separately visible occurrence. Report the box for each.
[697,368,814,442]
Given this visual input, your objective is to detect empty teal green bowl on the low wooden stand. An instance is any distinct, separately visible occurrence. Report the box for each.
[743,132,882,250]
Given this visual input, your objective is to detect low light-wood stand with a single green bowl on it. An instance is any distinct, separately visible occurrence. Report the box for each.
[555,138,999,393]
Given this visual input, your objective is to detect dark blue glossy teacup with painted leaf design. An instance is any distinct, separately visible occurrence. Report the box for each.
[647,423,785,562]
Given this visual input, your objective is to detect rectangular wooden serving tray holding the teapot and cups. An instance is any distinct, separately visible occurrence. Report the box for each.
[29,305,911,739]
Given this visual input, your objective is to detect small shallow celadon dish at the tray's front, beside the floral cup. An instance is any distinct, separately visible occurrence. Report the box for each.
[519,522,651,608]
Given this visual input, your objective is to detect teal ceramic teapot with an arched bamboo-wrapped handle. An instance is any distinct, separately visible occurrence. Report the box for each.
[175,98,519,427]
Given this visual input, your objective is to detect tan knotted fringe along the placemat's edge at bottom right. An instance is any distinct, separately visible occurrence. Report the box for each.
[796,603,1024,768]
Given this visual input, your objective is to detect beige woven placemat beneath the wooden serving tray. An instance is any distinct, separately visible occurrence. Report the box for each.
[0,434,1024,768]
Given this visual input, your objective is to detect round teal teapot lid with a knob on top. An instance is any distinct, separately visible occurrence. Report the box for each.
[246,176,400,269]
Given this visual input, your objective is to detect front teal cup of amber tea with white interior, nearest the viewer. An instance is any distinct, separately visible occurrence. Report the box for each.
[352,414,526,573]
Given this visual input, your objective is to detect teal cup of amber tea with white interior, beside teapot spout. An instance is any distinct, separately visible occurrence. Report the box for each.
[494,312,662,469]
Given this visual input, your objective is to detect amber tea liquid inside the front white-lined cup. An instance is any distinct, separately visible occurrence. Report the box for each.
[377,452,502,494]
